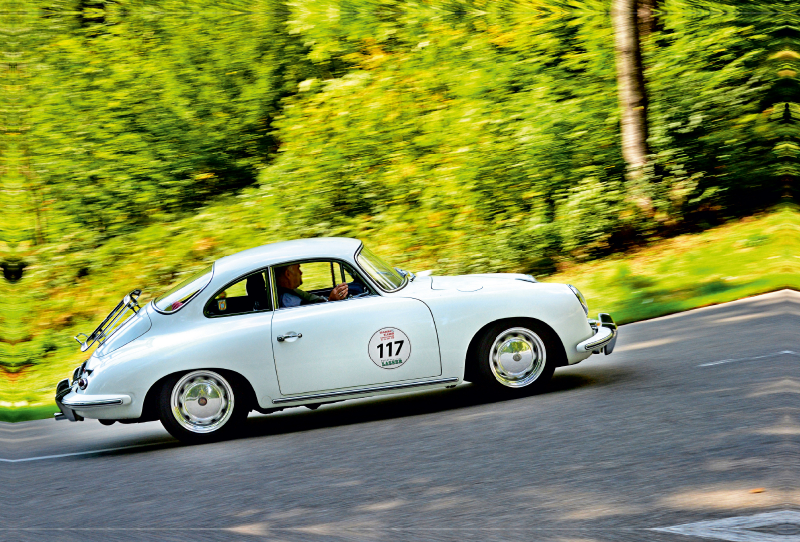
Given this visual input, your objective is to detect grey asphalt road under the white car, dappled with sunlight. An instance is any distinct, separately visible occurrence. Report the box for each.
[0,291,800,542]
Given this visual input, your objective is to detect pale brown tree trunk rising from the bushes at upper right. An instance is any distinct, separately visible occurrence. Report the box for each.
[611,0,650,178]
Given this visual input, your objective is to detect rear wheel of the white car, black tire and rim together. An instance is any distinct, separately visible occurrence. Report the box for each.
[158,369,250,444]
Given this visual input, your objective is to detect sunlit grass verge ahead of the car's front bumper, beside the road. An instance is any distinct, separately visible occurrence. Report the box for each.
[546,206,800,323]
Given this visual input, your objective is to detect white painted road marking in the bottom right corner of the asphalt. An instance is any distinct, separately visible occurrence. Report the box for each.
[653,510,800,542]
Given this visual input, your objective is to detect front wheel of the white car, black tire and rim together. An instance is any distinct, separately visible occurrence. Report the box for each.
[468,319,565,397]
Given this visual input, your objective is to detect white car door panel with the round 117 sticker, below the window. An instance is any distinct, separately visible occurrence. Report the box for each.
[272,295,442,395]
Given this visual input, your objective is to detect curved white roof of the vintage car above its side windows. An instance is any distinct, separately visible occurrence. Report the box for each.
[214,237,361,278]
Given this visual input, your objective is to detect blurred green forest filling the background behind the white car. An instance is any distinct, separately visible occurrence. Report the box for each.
[0,0,800,412]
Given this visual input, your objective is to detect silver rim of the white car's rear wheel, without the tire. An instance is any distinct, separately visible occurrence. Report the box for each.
[170,371,233,433]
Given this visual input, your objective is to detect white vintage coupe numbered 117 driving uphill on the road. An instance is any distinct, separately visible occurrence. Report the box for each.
[55,238,617,442]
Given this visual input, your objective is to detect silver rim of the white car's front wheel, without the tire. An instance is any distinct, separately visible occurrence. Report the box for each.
[489,327,547,388]
